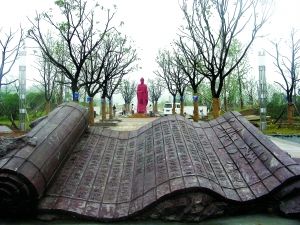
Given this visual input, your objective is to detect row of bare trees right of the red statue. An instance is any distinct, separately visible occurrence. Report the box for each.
[155,0,300,123]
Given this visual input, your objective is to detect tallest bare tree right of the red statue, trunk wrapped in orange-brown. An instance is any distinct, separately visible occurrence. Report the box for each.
[181,0,270,117]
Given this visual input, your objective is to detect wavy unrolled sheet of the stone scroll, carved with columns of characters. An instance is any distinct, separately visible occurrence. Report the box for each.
[39,113,300,220]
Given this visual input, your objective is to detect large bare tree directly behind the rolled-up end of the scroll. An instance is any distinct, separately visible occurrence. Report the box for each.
[28,0,114,101]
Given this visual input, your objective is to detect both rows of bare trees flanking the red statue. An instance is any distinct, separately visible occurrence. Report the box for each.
[0,0,299,125]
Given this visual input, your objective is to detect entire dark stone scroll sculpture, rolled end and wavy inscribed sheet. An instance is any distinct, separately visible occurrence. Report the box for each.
[0,104,300,221]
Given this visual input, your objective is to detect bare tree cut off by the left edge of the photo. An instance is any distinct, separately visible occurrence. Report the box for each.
[0,28,23,91]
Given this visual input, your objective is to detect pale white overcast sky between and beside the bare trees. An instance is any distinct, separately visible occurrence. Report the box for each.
[0,0,300,89]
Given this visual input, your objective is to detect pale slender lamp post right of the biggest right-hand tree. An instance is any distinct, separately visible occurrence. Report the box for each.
[258,50,267,131]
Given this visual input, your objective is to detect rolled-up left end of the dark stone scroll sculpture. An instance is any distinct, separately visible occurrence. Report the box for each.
[0,103,87,215]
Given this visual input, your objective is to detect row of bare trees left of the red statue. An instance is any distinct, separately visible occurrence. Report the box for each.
[0,0,138,125]
